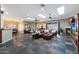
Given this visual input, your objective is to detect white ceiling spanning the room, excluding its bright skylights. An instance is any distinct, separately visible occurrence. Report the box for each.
[2,4,79,21]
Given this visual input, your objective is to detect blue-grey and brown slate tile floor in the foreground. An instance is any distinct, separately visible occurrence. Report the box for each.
[0,34,76,54]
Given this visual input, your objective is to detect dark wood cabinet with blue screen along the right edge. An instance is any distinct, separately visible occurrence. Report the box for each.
[71,14,79,53]
